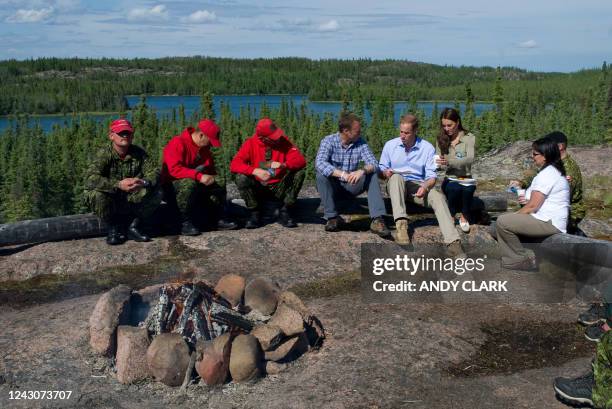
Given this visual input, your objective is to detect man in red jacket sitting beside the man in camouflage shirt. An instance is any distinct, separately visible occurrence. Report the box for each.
[161,119,238,236]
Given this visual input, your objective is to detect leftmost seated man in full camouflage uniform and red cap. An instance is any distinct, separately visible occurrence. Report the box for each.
[84,119,161,245]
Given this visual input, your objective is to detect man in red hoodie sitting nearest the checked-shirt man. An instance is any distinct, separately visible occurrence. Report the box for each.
[230,118,306,229]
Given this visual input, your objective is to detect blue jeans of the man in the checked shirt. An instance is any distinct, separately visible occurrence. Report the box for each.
[317,172,387,219]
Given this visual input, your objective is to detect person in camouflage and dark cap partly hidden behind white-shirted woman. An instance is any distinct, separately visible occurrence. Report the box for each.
[511,131,586,235]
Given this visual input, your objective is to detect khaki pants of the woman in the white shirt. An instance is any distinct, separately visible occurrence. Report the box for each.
[495,213,561,264]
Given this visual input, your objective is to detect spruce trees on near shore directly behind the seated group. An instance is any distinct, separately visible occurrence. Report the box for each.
[0,65,612,223]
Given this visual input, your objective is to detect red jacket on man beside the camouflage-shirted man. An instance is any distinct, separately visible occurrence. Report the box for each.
[161,128,217,184]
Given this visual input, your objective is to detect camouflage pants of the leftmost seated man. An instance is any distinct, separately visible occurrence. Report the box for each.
[85,189,161,223]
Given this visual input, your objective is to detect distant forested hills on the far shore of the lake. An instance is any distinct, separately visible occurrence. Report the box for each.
[0,57,599,115]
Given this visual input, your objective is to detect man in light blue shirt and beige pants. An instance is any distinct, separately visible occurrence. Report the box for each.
[379,114,463,256]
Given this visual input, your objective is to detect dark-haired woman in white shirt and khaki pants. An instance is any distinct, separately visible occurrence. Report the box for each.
[495,137,570,270]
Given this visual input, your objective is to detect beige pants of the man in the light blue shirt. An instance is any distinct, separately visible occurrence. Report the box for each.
[387,174,459,244]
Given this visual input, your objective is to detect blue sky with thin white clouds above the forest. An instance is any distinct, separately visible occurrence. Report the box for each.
[0,0,612,72]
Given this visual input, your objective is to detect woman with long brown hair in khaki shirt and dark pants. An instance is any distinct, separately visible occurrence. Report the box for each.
[436,108,476,233]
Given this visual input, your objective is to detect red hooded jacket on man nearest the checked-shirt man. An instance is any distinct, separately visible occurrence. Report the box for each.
[230,135,306,183]
